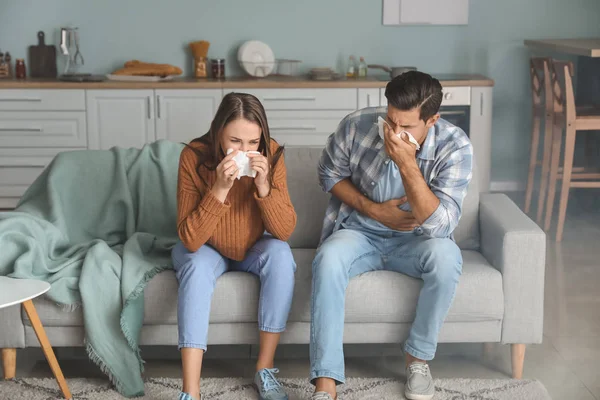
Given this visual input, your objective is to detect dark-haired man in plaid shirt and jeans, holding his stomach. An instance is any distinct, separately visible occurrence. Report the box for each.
[310,71,473,400]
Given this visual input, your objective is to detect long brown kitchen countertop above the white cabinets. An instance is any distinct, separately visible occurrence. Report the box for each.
[0,74,494,89]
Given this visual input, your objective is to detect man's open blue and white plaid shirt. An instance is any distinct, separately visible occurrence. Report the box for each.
[319,107,473,242]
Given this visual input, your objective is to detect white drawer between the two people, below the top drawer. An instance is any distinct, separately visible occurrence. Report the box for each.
[268,111,347,146]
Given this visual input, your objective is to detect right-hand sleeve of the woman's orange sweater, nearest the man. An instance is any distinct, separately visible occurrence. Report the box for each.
[254,151,296,241]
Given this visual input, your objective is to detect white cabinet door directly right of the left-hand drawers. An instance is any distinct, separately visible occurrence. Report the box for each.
[86,89,156,149]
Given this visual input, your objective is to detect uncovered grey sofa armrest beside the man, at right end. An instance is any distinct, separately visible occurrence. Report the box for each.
[479,193,546,344]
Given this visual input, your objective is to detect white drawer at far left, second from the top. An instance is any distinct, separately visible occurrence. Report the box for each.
[0,111,87,147]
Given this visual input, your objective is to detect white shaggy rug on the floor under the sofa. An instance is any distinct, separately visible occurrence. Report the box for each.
[0,378,550,400]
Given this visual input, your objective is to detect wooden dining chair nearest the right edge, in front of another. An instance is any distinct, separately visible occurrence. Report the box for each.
[544,60,600,242]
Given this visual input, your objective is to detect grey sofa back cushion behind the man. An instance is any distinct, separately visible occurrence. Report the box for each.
[285,147,479,250]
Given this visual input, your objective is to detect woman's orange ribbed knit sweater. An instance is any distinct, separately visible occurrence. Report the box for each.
[177,141,296,261]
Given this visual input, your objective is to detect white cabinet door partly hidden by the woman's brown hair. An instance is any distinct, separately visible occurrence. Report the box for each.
[156,89,223,143]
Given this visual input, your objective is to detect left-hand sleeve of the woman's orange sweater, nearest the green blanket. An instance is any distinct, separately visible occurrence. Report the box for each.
[177,149,230,252]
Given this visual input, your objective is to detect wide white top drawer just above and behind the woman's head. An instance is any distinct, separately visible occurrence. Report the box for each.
[224,89,357,111]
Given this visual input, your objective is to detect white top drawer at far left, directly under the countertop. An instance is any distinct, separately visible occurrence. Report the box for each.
[0,89,85,111]
